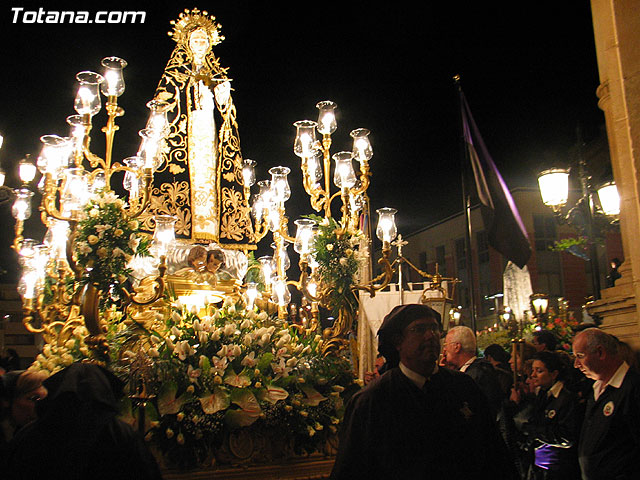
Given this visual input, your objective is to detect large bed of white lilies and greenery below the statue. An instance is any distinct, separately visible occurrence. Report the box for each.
[32,298,360,468]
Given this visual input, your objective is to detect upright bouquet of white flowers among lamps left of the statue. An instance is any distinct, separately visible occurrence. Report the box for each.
[74,190,151,308]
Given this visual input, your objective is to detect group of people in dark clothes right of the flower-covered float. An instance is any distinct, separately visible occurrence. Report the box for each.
[331,305,640,480]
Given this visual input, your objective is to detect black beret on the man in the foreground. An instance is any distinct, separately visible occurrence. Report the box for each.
[378,303,442,367]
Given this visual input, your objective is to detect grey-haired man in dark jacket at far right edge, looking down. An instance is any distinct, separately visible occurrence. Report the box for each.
[573,328,640,480]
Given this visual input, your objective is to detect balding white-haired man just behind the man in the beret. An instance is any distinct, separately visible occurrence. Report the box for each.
[443,326,505,415]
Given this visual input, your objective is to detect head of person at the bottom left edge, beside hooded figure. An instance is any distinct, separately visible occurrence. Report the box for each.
[2,370,47,427]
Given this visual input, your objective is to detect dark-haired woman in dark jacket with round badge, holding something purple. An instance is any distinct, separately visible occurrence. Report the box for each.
[512,352,581,480]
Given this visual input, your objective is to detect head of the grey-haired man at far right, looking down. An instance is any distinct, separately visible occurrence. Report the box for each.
[572,328,622,381]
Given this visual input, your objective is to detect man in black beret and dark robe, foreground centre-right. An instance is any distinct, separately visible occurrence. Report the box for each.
[331,305,515,479]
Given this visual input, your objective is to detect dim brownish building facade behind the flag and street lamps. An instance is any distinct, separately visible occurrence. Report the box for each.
[404,188,624,328]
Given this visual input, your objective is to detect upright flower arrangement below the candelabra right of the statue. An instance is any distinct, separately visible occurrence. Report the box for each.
[309,215,367,317]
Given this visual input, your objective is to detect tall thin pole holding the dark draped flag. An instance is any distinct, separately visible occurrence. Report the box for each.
[453,75,477,334]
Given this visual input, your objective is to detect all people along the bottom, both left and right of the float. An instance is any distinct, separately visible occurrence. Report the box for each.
[0,304,640,480]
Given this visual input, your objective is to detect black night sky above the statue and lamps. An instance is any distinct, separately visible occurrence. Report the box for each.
[0,0,604,278]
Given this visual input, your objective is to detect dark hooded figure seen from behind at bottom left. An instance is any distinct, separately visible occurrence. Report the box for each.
[3,363,162,480]
